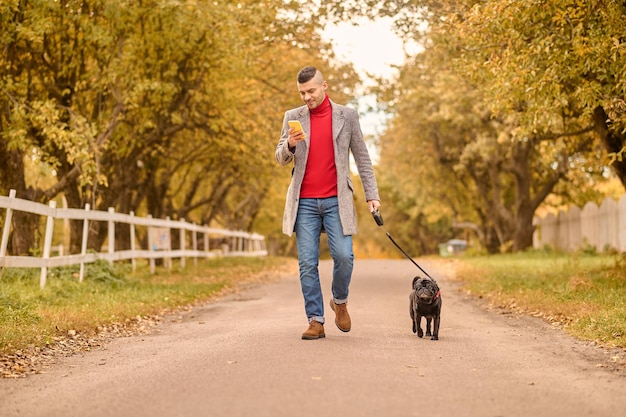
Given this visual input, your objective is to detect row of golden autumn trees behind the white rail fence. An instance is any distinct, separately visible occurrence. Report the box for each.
[0,0,357,253]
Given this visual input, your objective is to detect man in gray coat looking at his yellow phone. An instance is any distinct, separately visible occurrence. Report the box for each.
[276,66,380,340]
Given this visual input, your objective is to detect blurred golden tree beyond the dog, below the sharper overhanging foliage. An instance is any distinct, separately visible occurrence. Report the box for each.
[380,52,589,252]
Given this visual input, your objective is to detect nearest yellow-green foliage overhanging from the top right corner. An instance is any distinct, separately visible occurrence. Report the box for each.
[429,0,626,187]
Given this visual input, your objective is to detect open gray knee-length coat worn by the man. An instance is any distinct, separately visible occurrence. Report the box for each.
[276,101,380,236]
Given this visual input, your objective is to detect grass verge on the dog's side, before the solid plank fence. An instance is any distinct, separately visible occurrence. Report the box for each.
[457,252,626,348]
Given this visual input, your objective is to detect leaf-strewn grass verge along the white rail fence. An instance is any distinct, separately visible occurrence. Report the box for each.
[0,257,297,356]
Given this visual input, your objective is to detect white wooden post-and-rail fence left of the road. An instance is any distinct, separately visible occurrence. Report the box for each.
[0,190,267,288]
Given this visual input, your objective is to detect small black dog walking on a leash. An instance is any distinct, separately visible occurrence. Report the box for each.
[409,277,441,340]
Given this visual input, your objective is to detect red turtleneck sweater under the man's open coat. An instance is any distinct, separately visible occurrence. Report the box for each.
[300,95,337,198]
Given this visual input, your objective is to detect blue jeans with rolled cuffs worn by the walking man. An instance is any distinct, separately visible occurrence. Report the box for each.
[295,197,354,323]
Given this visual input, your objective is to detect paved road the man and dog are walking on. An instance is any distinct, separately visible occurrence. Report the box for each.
[0,260,626,417]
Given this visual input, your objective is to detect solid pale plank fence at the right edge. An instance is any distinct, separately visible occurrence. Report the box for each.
[533,194,626,252]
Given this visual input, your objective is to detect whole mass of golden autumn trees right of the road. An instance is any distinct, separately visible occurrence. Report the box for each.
[326,0,626,252]
